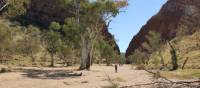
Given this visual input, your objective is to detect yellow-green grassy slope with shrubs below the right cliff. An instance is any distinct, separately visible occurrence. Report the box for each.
[147,32,200,70]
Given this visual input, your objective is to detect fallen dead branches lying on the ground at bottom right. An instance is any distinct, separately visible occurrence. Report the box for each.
[120,69,200,88]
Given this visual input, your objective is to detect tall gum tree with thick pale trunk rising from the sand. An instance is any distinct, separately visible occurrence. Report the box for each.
[71,0,127,70]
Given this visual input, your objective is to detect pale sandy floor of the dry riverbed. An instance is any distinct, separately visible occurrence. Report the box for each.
[0,65,151,88]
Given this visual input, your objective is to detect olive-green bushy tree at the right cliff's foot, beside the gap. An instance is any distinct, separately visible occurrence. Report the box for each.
[128,31,164,66]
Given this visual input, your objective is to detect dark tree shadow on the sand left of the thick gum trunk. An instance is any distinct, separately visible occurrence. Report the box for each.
[23,69,82,80]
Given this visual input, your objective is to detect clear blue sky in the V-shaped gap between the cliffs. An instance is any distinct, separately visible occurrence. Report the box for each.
[109,0,167,52]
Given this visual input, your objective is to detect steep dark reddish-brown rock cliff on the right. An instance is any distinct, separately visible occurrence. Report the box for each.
[126,0,200,57]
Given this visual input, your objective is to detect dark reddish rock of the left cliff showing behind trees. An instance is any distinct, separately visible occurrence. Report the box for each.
[27,0,120,54]
